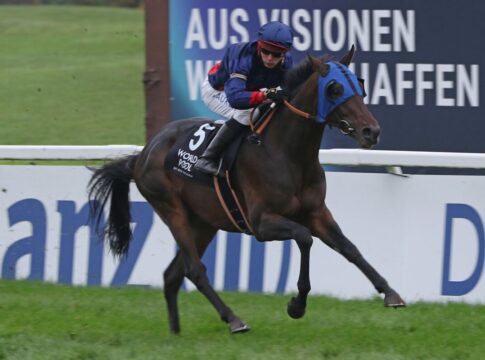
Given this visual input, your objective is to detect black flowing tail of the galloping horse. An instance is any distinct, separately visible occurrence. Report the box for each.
[88,155,138,256]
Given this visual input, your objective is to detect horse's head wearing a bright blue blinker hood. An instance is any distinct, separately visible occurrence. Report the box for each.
[309,46,381,148]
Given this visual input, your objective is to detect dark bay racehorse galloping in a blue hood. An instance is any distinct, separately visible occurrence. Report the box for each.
[89,47,405,333]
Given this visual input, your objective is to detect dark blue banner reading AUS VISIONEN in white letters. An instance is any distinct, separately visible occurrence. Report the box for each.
[170,0,485,152]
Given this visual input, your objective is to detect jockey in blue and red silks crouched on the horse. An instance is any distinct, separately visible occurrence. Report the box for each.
[195,21,293,175]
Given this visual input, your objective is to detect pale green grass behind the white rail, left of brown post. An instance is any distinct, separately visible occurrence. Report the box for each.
[0,5,145,145]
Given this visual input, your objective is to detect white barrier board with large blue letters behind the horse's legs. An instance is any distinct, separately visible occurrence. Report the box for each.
[0,166,485,303]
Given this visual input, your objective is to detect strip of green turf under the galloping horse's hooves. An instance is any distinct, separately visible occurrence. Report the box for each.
[0,280,485,360]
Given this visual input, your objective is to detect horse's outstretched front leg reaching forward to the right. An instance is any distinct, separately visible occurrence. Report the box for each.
[310,207,406,307]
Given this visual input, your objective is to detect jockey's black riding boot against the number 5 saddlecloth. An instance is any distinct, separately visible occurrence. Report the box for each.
[194,119,246,175]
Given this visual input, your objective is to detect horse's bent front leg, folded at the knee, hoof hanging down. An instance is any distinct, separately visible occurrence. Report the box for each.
[255,214,313,319]
